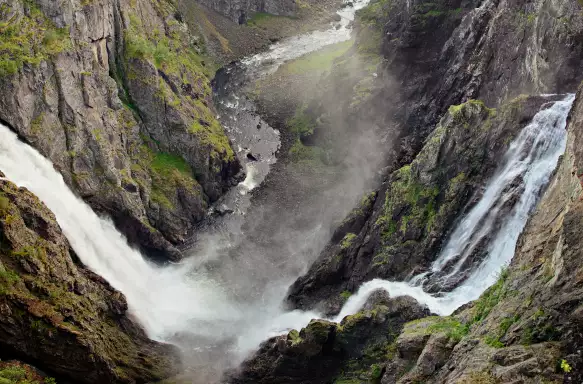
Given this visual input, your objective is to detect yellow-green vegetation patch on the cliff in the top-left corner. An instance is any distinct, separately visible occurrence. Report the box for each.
[0,0,71,76]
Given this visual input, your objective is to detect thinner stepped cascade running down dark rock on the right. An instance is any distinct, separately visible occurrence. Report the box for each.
[332,95,575,321]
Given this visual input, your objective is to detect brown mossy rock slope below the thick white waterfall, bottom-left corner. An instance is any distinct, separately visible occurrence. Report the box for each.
[0,174,179,383]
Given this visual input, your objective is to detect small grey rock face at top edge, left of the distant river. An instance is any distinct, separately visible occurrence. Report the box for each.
[199,0,298,24]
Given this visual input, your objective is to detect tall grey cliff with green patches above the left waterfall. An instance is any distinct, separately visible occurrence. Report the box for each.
[0,0,240,258]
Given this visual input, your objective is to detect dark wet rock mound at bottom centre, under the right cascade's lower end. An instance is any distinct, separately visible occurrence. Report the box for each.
[225,292,429,384]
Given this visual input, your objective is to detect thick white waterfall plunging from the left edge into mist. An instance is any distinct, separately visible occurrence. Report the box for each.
[0,125,244,339]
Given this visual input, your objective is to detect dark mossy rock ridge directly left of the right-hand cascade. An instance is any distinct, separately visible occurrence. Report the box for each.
[289,97,552,312]
